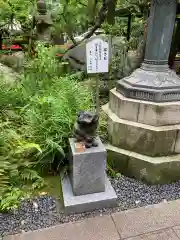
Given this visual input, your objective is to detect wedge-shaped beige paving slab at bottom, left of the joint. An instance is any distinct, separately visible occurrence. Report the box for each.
[4,216,119,240]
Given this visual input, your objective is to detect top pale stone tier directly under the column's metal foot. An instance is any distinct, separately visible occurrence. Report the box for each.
[109,88,180,126]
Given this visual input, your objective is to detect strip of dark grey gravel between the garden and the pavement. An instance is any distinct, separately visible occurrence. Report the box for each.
[0,176,180,236]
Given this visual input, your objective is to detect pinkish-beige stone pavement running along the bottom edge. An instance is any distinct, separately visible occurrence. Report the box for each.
[3,200,180,240]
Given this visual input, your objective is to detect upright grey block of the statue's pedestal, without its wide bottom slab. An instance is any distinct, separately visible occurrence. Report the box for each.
[70,138,106,196]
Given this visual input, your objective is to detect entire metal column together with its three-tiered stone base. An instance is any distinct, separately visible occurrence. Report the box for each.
[104,0,180,184]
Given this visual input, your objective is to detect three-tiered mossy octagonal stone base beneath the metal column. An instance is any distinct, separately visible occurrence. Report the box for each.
[103,89,180,184]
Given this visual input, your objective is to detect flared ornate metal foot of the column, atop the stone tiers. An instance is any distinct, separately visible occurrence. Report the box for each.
[117,63,180,102]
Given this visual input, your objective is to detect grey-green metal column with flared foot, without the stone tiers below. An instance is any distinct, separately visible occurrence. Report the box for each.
[116,0,180,102]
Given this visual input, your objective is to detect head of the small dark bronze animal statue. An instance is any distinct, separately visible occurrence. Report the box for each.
[77,111,99,125]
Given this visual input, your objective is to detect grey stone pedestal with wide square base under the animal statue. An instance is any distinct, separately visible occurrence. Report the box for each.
[61,138,117,213]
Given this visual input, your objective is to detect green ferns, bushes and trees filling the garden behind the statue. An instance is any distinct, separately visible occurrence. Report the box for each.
[0,0,153,211]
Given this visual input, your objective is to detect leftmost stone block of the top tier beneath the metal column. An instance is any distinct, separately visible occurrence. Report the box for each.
[109,88,140,122]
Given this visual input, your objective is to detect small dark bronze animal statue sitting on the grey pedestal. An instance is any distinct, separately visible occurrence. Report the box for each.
[74,111,99,148]
